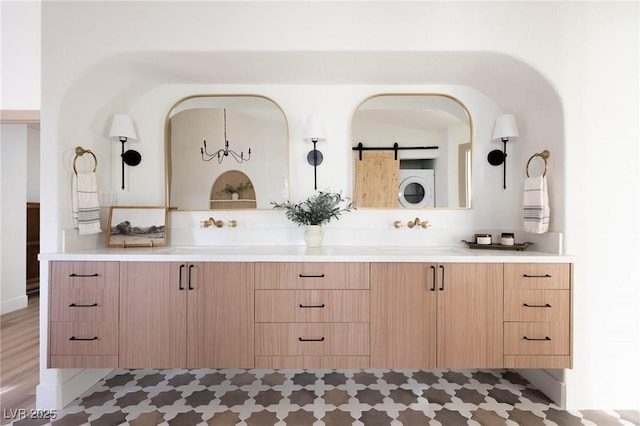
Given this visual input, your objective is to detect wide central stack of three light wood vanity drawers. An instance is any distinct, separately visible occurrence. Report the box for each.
[255,262,369,369]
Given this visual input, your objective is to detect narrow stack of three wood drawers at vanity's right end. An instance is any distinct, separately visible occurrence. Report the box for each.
[504,263,572,368]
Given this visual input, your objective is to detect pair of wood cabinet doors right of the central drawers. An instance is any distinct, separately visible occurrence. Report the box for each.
[371,263,503,369]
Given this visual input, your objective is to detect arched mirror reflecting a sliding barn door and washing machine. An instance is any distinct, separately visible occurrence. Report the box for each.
[351,94,473,209]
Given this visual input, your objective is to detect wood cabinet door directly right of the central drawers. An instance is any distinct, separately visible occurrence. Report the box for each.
[370,263,438,368]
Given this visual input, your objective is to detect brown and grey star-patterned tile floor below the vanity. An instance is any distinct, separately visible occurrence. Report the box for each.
[14,369,640,426]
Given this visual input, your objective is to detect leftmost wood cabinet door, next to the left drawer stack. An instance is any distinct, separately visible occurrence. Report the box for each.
[119,262,187,368]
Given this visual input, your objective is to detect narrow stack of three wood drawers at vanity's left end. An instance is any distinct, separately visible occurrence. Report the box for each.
[49,261,120,368]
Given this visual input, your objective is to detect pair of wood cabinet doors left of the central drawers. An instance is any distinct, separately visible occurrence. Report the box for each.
[119,262,254,368]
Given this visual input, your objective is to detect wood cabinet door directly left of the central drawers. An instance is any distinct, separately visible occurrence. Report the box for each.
[187,262,254,368]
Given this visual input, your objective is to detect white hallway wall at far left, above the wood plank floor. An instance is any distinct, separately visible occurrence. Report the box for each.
[0,124,28,314]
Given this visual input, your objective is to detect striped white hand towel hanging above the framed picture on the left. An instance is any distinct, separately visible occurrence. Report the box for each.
[71,173,102,235]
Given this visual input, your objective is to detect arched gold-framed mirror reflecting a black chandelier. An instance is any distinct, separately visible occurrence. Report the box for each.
[165,95,289,210]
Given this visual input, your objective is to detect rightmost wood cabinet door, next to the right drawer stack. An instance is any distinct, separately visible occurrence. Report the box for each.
[437,263,503,368]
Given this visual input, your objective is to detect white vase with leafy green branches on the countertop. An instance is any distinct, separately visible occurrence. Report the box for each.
[271,191,355,247]
